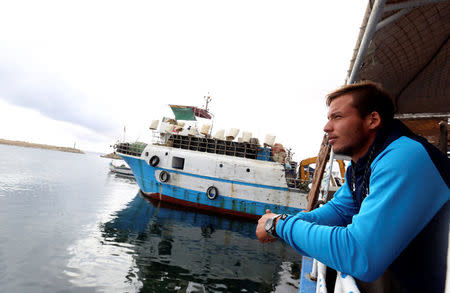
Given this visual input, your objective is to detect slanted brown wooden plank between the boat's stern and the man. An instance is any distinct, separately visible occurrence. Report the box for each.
[306,134,331,212]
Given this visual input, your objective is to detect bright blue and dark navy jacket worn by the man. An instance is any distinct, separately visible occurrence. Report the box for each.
[276,121,450,292]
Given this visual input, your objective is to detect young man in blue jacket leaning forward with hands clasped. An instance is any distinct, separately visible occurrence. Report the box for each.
[256,82,450,292]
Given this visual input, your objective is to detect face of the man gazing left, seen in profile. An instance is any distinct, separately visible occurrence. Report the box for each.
[323,94,371,161]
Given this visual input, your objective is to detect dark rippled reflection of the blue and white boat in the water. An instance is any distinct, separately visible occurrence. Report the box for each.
[101,194,299,292]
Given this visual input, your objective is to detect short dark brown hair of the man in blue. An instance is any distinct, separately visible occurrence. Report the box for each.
[327,80,394,122]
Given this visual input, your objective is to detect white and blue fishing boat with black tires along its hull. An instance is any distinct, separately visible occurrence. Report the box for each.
[115,97,307,218]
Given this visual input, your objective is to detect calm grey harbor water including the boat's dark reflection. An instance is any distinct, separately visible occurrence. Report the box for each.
[0,145,299,292]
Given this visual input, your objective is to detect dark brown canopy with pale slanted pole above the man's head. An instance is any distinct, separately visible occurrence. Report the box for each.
[347,0,450,118]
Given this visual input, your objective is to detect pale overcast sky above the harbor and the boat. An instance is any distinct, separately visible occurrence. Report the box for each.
[0,0,367,159]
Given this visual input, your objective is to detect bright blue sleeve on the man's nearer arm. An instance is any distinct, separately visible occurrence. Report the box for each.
[277,137,450,281]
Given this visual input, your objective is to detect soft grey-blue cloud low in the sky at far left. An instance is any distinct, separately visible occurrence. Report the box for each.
[0,62,120,133]
